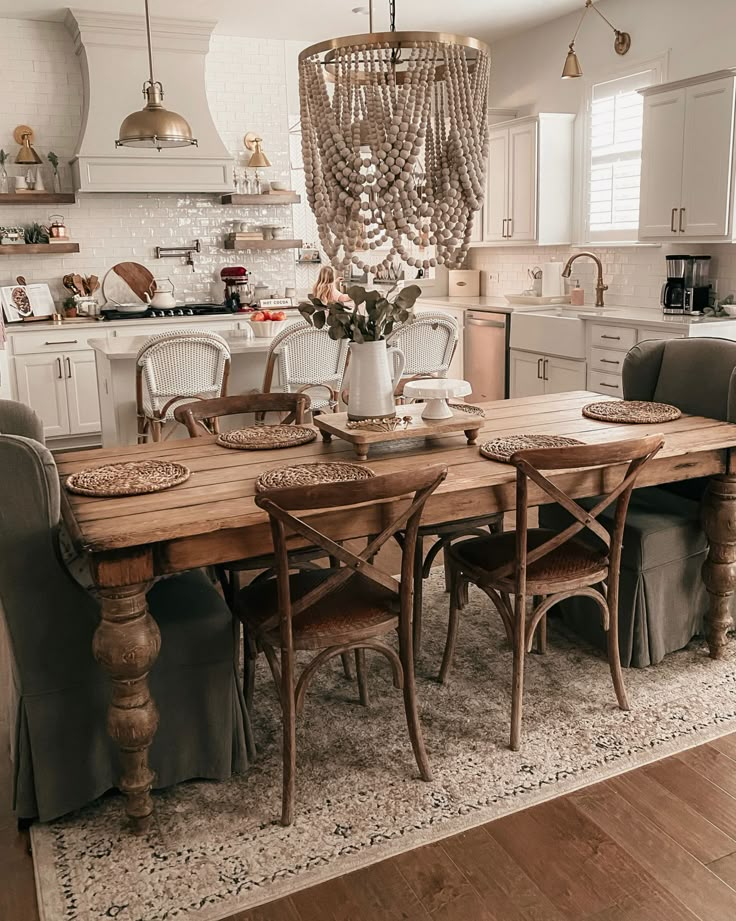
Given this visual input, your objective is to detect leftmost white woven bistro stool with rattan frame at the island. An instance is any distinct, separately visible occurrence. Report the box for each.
[135,329,230,444]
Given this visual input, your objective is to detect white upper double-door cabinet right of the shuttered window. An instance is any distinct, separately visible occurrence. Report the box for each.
[639,71,736,242]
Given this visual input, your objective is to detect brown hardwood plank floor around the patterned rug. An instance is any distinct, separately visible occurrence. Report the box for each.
[0,726,736,921]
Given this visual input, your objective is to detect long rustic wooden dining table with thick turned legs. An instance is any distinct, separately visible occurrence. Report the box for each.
[57,392,736,831]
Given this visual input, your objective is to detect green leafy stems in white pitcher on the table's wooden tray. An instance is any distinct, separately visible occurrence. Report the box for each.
[299,285,422,420]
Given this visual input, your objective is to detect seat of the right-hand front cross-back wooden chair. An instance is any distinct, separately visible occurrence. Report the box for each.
[450,528,608,594]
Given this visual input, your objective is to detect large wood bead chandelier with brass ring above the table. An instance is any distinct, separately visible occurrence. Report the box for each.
[299,2,490,275]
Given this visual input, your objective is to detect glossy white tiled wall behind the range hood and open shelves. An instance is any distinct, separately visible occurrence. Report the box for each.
[0,19,296,300]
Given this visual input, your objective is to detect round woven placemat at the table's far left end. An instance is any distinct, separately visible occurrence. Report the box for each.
[66,460,190,499]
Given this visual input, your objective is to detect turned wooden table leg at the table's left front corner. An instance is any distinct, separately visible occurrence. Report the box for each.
[92,585,161,834]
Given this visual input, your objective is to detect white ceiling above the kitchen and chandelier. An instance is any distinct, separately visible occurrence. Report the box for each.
[0,0,585,42]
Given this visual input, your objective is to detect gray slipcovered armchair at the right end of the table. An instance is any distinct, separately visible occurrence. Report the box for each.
[539,338,736,668]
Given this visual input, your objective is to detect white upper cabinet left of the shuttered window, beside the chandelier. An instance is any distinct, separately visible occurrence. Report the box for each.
[483,113,575,245]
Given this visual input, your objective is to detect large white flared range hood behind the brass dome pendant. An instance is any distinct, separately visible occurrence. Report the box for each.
[66,9,233,192]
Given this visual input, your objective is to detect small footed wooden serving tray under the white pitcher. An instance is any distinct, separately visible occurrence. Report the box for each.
[314,403,485,460]
